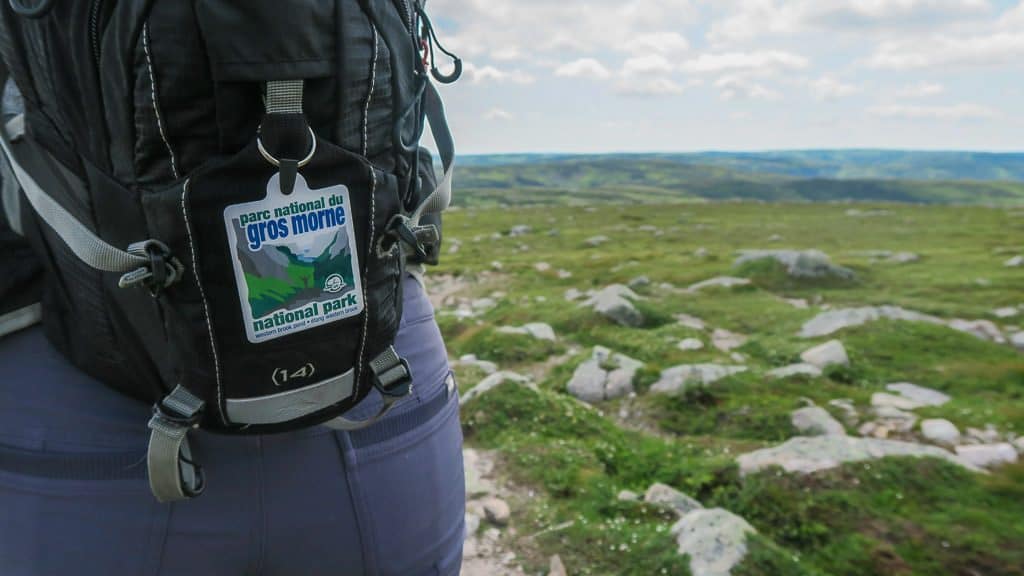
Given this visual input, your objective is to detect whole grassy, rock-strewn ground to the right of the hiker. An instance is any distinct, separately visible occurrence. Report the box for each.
[429,206,1024,576]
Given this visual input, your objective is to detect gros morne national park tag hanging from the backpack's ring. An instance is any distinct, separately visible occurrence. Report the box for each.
[224,174,364,343]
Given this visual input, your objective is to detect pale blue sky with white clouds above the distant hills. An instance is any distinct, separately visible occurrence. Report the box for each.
[427,0,1024,154]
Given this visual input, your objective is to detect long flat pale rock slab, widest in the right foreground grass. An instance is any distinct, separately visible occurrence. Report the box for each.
[737,436,976,475]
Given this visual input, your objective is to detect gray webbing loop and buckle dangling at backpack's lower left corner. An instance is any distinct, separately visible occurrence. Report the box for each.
[146,386,203,502]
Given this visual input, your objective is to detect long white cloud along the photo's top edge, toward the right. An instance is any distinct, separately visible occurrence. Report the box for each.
[709,0,991,42]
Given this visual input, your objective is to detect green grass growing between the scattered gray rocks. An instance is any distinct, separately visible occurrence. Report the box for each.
[444,203,1024,576]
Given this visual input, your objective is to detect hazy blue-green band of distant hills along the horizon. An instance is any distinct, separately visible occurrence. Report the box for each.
[456,151,1024,206]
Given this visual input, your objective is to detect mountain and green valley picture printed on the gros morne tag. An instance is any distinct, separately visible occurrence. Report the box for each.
[237,230,355,319]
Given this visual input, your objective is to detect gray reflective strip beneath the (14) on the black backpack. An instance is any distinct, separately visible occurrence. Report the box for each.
[224,370,355,424]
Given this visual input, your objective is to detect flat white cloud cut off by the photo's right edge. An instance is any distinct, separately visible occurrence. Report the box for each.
[866,31,1024,70]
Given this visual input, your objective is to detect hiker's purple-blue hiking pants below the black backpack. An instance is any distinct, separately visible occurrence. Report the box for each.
[0,278,465,576]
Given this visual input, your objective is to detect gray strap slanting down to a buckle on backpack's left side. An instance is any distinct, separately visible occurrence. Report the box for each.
[0,120,150,273]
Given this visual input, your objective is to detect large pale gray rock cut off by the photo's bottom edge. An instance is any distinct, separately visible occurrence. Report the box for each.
[672,508,757,576]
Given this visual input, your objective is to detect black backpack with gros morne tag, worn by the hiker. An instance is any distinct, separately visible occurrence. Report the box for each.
[0,0,461,501]
